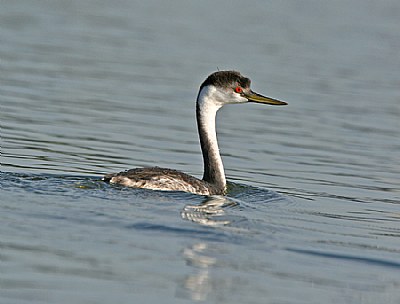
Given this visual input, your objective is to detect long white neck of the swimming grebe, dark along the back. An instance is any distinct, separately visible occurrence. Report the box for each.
[196,86,226,191]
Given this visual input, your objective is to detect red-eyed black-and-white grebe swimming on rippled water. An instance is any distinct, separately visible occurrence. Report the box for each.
[103,70,287,196]
